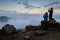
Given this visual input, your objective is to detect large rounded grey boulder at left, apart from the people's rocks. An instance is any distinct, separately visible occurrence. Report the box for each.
[2,24,16,34]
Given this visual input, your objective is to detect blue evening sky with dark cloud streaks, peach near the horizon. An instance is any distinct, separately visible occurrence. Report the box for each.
[0,0,60,14]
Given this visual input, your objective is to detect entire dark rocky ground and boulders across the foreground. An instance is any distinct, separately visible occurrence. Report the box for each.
[0,20,60,40]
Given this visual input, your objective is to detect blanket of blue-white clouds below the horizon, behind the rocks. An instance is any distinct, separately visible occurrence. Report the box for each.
[0,14,60,29]
